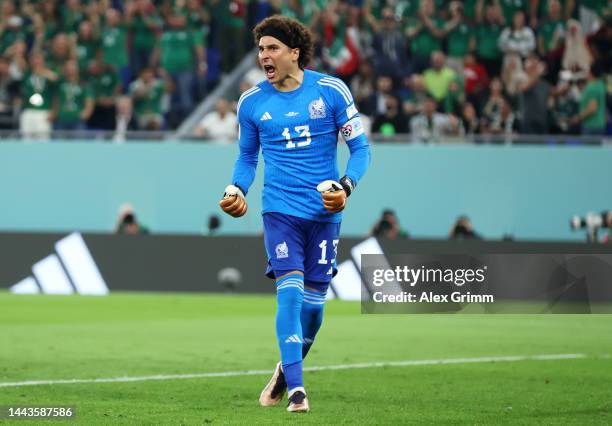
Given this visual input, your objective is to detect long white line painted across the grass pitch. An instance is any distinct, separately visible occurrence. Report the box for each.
[0,354,587,388]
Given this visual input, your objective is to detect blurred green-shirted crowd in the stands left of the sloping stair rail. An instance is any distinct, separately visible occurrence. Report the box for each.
[0,0,253,139]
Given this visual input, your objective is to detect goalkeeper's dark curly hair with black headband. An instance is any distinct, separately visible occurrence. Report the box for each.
[253,15,314,69]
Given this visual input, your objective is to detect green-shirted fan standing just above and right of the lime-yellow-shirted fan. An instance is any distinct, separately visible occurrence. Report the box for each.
[444,1,476,75]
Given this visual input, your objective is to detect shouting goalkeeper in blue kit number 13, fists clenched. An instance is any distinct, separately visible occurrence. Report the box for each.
[220,15,370,412]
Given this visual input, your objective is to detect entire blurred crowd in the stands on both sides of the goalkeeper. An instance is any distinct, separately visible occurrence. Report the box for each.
[0,0,612,141]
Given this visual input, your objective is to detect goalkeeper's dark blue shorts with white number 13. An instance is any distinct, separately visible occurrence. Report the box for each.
[263,213,340,282]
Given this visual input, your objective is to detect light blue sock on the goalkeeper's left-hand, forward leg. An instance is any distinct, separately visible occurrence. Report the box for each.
[276,274,304,390]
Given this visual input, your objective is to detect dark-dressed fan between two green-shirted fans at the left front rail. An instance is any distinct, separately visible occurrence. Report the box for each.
[87,59,121,130]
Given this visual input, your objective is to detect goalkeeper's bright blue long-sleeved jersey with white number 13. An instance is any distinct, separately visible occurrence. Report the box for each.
[233,70,370,223]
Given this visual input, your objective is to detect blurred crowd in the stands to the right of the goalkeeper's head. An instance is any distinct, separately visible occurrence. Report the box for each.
[231,0,612,142]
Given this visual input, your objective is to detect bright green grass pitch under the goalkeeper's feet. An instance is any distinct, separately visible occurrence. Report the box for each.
[0,292,612,425]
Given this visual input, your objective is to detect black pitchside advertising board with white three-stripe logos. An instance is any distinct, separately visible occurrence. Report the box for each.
[0,233,612,314]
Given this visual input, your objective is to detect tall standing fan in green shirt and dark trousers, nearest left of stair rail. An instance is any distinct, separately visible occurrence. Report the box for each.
[152,12,207,127]
